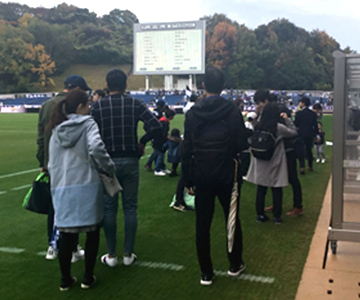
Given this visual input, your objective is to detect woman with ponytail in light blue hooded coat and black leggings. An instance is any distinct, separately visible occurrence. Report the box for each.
[47,90,115,291]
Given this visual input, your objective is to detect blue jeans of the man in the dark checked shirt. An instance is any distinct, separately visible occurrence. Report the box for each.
[104,157,139,256]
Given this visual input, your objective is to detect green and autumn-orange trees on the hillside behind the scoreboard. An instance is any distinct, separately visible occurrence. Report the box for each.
[0,2,353,93]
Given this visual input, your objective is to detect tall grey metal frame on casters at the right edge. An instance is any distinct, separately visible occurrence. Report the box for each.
[328,51,360,254]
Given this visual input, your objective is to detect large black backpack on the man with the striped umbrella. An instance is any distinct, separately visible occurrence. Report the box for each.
[191,120,233,183]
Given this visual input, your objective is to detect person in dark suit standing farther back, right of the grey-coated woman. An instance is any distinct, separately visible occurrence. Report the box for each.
[294,97,319,174]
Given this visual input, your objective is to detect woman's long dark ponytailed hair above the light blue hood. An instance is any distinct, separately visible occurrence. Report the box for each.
[46,90,89,131]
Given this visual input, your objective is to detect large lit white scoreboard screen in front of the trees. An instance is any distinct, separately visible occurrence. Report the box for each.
[134,21,205,75]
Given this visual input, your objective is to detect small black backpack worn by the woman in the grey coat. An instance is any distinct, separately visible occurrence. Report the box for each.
[249,130,276,160]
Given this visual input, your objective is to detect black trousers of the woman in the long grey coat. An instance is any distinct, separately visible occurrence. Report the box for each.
[256,185,283,218]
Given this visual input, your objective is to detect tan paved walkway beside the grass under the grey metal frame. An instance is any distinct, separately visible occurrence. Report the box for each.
[295,179,360,300]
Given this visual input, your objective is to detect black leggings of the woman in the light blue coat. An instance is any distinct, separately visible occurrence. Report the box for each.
[59,228,100,283]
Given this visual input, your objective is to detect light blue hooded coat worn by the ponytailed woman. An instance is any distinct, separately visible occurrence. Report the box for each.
[48,114,115,228]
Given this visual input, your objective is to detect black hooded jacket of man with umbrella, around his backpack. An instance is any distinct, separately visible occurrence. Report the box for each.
[182,96,248,187]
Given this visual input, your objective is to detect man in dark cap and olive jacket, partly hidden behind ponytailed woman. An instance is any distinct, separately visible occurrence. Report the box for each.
[36,75,91,262]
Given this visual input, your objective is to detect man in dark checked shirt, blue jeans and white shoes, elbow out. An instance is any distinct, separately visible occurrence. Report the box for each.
[90,69,162,267]
